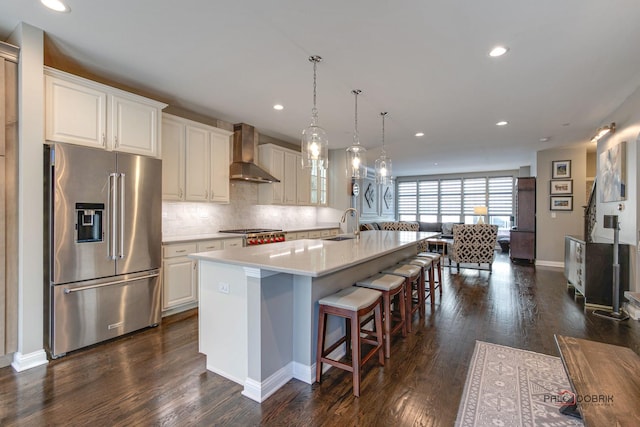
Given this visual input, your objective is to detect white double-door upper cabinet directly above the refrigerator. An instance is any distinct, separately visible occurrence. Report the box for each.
[45,67,166,157]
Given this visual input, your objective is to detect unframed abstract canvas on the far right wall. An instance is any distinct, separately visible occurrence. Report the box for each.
[598,141,627,202]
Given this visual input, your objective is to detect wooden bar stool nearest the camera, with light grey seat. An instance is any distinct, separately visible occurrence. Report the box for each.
[316,286,384,397]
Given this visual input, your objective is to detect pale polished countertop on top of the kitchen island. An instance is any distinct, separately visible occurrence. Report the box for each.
[189,230,438,277]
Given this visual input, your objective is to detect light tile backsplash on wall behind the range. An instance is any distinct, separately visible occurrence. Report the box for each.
[162,181,340,237]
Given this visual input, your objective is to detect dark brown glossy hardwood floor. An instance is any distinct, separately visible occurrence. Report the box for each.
[0,254,640,426]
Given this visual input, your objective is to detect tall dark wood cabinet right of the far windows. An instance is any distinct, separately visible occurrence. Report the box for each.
[509,178,536,262]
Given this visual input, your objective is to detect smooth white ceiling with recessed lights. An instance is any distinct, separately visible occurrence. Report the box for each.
[0,0,640,176]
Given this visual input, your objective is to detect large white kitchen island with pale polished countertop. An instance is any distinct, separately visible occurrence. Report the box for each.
[190,230,436,402]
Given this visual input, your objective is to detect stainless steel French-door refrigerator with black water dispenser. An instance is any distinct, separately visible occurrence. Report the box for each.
[44,144,162,358]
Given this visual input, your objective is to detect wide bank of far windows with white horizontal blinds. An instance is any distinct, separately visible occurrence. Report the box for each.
[397,174,515,229]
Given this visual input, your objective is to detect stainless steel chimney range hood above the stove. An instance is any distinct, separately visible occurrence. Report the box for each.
[229,123,280,183]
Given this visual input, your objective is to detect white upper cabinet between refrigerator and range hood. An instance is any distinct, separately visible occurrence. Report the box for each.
[162,114,233,203]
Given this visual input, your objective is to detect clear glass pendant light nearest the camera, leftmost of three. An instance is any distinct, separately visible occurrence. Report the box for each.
[300,55,329,169]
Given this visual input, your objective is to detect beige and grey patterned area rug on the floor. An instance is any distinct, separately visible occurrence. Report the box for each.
[456,341,582,427]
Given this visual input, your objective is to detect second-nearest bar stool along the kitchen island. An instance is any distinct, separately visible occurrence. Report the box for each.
[356,274,407,359]
